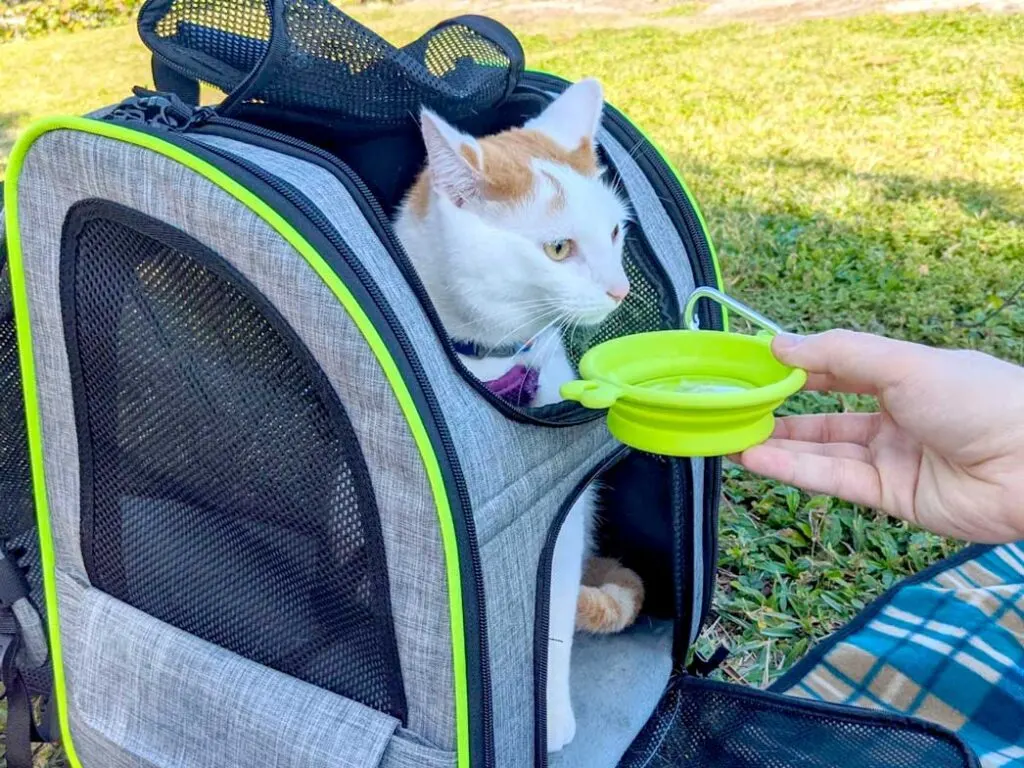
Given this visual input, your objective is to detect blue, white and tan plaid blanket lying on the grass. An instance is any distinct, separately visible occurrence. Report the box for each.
[772,543,1024,768]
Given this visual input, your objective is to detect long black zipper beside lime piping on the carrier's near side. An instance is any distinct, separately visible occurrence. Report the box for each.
[104,99,495,768]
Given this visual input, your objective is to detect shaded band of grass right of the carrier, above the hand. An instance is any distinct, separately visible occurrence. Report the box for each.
[687,157,1024,362]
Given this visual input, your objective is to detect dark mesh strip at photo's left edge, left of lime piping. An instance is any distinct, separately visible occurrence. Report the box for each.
[0,246,35,539]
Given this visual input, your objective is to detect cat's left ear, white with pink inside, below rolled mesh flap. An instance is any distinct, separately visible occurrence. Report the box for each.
[420,108,483,206]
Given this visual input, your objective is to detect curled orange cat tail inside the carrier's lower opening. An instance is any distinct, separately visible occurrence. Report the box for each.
[575,557,644,634]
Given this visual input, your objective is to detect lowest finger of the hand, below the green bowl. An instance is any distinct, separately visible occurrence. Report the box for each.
[736,440,882,509]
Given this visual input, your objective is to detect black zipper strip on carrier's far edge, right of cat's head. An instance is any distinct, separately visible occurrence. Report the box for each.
[519,72,722,330]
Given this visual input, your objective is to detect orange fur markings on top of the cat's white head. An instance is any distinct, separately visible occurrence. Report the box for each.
[409,128,600,218]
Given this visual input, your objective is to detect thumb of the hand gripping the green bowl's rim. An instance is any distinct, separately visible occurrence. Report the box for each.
[772,331,927,394]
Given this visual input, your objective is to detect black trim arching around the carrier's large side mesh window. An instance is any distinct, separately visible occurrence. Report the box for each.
[59,199,408,724]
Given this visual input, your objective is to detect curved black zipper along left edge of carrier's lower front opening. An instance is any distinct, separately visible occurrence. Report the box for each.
[534,445,631,768]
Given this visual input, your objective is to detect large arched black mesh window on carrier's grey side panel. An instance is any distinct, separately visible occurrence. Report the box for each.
[61,202,406,720]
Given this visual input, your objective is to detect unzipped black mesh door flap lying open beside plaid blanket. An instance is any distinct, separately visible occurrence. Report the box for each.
[618,678,977,768]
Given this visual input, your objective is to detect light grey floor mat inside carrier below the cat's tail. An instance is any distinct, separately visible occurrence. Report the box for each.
[548,616,672,768]
